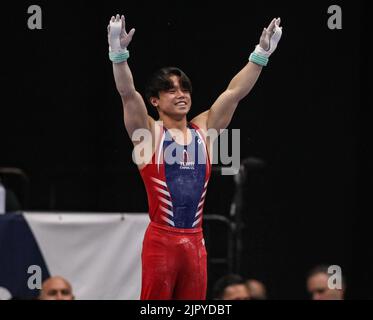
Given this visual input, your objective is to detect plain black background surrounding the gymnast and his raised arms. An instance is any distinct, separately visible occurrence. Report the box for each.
[0,1,372,299]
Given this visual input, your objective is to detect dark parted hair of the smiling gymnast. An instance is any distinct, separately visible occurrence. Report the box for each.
[145,67,192,103]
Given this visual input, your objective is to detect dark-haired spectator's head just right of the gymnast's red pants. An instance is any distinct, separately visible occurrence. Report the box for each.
[213,274,250,300]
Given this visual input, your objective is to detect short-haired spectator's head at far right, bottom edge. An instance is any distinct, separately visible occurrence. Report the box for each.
[307,265,346,300]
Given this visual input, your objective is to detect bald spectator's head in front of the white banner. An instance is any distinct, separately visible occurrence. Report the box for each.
[39,276,75,300]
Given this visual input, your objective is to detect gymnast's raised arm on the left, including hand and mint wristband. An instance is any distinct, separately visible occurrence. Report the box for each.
[108,15,151,137]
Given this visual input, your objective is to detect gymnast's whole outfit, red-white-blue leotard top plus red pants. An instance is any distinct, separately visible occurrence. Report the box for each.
[140,123,211,300]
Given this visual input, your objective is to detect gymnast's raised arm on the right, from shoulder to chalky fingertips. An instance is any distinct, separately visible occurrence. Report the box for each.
[192,18,282,132]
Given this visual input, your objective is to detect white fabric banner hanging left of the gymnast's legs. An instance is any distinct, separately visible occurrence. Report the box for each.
[24,212,149,300]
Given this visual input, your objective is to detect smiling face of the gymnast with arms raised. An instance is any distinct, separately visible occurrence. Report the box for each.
[150,75,192,119]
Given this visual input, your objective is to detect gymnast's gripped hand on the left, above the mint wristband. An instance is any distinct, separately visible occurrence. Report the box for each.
[107,14,135,52]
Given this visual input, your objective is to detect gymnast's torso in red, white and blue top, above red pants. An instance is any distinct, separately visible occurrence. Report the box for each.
[139,123,211,231]
